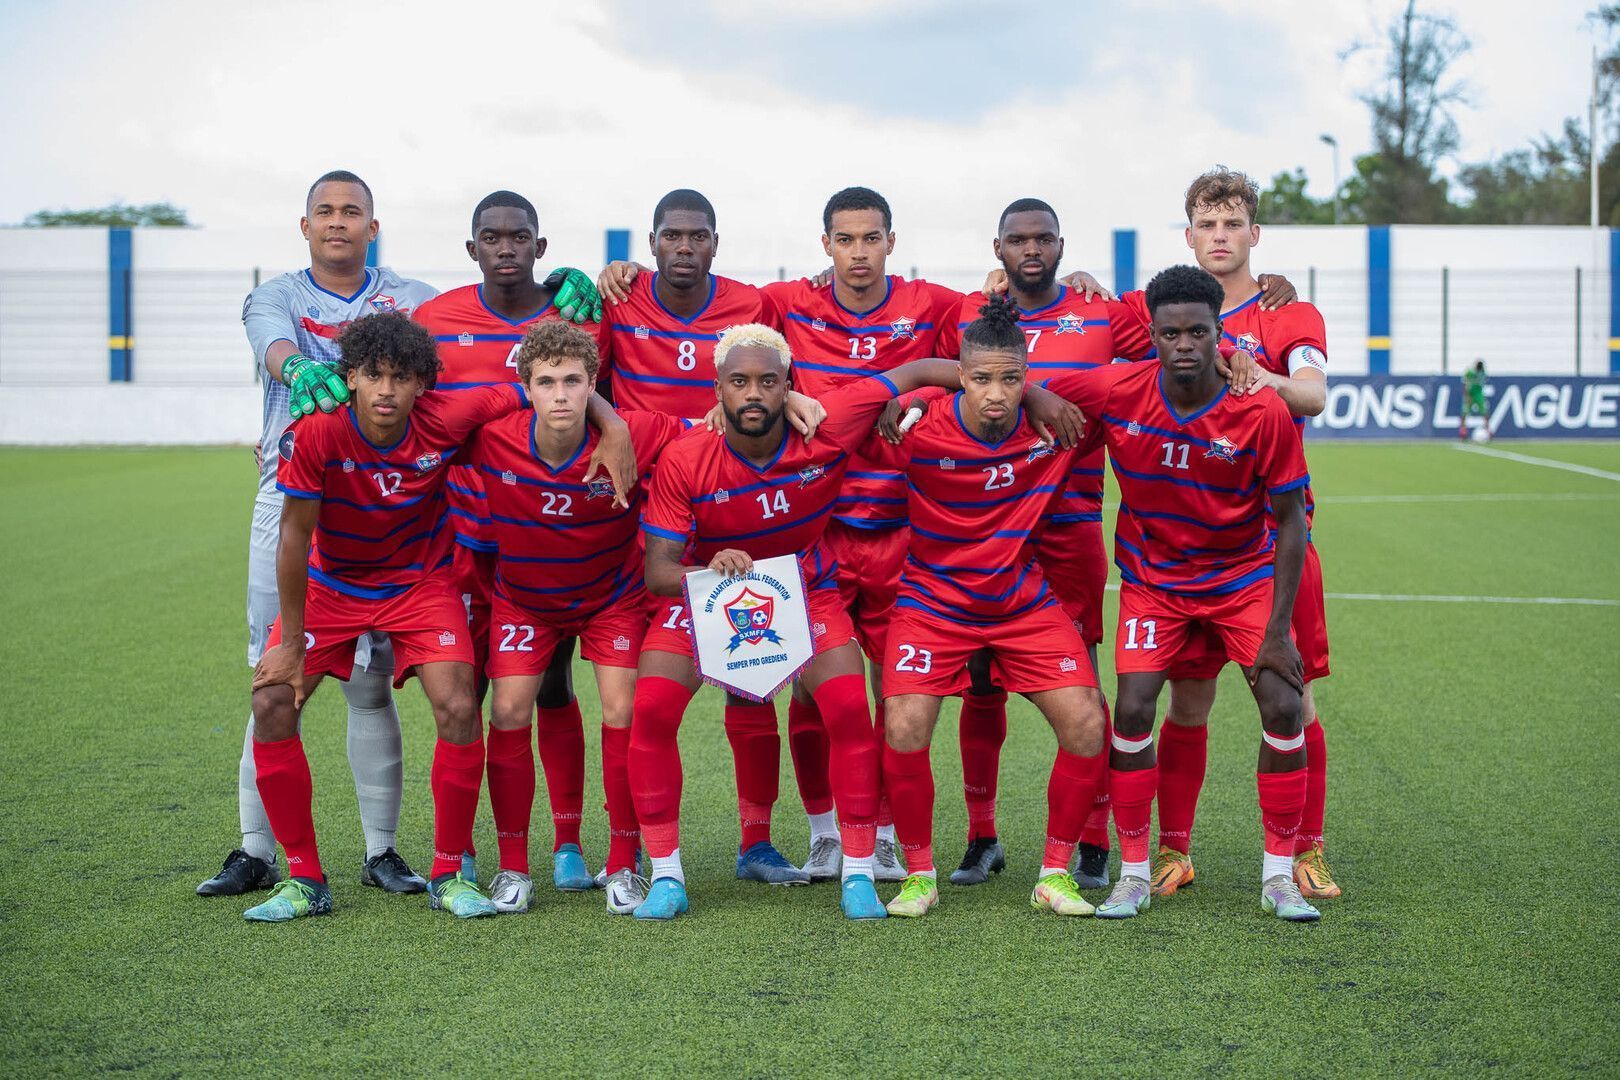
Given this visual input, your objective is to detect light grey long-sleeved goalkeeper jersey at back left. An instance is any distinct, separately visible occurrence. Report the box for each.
[241,267,437,505]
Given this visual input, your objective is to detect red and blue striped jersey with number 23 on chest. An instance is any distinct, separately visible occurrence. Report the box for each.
[867,393,1102,625]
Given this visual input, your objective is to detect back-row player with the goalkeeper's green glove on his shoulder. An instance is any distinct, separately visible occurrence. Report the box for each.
[415,191,615,908]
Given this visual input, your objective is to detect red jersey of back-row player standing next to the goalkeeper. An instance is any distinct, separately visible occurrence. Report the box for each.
[411,285,595,551]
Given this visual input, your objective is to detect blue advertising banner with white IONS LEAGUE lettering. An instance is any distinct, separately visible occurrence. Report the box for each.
[1306,376,1620,439]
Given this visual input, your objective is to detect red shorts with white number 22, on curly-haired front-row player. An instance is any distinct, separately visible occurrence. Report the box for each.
[486,586,646,678]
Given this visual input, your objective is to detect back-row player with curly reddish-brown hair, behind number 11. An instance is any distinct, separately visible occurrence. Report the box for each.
[1124,168,1340,897]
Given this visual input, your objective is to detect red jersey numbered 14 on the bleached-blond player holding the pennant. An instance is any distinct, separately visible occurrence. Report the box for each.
[642,376,894,589]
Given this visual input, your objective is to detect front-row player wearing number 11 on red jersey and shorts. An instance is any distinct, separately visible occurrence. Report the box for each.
[1047,267,1319,921]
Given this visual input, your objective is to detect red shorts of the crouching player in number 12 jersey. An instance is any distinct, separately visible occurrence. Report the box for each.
[267,576,473,687]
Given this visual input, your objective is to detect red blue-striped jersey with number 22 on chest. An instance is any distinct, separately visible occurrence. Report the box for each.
[463,413,687,619]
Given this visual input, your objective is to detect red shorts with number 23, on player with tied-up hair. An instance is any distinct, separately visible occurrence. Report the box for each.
[883,604,1097,698]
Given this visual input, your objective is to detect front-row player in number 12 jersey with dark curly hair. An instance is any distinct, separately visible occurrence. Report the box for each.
[243,313,525,923]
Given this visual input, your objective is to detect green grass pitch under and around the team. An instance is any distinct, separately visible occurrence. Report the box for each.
[0,444,1620,1077]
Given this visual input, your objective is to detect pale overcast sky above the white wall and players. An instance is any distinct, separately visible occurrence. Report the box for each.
[0,0,1592,275]
